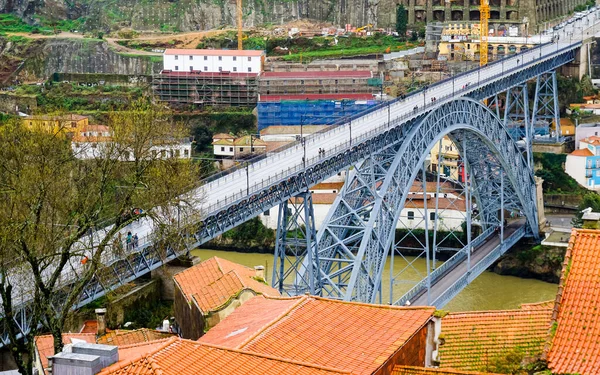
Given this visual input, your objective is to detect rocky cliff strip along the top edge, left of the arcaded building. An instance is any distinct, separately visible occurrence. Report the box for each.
[0,0,400,31]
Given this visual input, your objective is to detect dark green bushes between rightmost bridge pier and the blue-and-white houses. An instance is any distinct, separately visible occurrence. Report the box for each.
[533,152,588,195]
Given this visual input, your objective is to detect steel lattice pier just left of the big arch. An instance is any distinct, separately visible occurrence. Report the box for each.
[272,191,319,296]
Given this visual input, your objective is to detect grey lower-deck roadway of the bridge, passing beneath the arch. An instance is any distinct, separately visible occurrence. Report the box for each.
[410,221,524,306]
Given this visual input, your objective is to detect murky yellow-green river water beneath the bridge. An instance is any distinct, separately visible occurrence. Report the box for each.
[192,249,558,311]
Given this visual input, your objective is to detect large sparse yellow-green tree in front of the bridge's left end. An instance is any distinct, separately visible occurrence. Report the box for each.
[0,99,198,374]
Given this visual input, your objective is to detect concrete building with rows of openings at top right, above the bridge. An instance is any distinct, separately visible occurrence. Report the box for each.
[402,0,585,33]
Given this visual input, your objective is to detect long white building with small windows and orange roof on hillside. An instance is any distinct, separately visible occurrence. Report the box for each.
[163,49,265,74]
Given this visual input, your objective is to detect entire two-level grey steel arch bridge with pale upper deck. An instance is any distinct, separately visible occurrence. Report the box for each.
[0,9,600,344]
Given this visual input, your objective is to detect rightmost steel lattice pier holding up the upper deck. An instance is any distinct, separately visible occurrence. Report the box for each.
[531,70,560,140]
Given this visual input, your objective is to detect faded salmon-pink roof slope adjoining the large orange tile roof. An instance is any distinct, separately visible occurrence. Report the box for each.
[198,296,302,349]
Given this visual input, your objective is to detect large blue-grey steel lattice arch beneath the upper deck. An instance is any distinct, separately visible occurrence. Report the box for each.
[310,99,537,303]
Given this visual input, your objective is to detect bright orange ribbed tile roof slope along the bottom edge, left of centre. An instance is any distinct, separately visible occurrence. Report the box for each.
[99,339,349,375]
